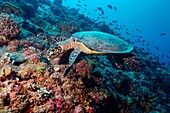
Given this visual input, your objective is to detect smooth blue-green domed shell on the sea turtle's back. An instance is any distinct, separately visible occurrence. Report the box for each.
[72,31,133,53]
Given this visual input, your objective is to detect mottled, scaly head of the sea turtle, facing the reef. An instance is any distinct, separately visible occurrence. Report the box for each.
[46,45,63,60]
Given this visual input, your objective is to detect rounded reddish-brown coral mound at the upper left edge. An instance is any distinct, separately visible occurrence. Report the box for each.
[0,14,20,44]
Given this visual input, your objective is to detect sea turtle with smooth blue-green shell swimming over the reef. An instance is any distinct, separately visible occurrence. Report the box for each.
[47,31,133,75]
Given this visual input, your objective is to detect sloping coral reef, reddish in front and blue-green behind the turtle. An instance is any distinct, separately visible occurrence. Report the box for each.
[0,0,170,113]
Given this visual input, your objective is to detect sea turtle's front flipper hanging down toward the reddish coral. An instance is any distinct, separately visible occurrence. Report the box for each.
[63,50,81,77]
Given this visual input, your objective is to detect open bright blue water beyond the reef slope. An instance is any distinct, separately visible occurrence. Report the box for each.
[63,0,170,66]
